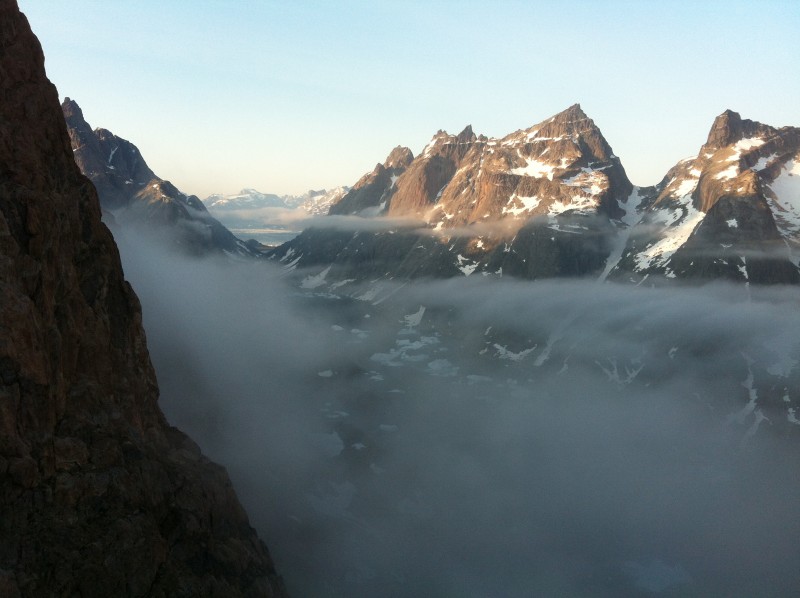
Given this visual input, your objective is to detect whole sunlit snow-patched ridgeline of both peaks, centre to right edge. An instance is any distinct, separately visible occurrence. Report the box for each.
[269,104,800,288]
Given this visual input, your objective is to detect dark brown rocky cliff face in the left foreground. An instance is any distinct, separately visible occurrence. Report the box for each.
[0,0,283,596]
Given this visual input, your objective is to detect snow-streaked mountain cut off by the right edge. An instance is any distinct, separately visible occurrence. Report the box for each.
[611,110,800,283]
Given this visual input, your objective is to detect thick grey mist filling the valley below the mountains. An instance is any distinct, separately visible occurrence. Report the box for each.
[115,230,800,597]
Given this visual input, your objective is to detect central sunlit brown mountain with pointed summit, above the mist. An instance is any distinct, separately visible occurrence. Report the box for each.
[271,104,634,280]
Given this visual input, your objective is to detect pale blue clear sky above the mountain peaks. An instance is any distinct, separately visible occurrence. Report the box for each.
[18,0,800,198]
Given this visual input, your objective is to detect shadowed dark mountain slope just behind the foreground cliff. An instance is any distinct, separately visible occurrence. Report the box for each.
[61,98,259,257]
